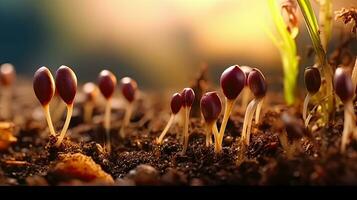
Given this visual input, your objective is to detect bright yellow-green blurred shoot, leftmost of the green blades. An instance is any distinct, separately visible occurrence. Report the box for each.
[266,0,299,105]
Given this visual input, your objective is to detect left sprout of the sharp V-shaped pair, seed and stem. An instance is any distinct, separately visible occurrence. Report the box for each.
[33,67,56,136]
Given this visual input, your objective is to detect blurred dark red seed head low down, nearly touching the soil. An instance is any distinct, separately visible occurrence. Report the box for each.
[281,112,306,141]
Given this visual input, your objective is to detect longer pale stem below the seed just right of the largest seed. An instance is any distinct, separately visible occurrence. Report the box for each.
[242,99,259,146]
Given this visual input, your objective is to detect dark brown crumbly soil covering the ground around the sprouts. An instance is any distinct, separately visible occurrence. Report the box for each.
[0,77,357,185]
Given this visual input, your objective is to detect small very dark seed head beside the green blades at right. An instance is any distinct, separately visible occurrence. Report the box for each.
[304,67,321,94]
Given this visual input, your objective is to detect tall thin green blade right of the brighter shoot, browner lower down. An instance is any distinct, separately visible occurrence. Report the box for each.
[297,0,334,123]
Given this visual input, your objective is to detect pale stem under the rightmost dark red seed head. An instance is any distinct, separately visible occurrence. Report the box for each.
[341,100,356,153]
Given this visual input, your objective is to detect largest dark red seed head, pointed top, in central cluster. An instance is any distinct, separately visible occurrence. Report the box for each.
[220,65,246,100]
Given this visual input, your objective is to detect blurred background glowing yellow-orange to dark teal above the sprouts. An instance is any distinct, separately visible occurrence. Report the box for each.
[0,0,356,89]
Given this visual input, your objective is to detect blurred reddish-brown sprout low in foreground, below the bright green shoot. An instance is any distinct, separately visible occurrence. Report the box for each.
[279,112,306,159]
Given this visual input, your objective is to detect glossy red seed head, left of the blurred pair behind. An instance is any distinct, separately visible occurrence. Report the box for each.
[98,70,117,99]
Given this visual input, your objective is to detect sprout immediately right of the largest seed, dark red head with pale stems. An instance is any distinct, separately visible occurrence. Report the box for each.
[242,68,267,146]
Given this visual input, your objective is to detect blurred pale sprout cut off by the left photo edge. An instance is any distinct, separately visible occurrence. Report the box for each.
[0,63,16,119]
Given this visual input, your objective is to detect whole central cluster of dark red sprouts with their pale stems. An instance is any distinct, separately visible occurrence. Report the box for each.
[157,65,267,153]
